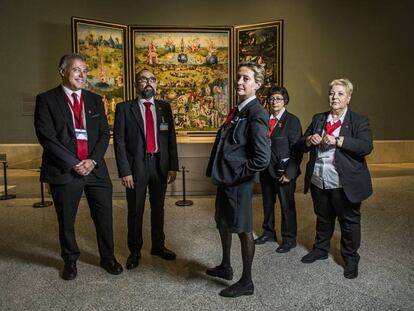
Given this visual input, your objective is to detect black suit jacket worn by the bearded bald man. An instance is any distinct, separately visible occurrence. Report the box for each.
[114,99,178,180]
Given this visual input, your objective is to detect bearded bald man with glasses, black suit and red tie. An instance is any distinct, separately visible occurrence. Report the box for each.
[114,69,178,269]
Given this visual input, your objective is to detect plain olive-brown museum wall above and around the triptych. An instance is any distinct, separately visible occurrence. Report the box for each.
[0,0,414,144]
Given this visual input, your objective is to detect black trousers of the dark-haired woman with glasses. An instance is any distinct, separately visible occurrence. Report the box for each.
[260,170,297,243]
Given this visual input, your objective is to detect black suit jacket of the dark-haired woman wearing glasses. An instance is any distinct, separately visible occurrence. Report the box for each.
[267,110,303,179]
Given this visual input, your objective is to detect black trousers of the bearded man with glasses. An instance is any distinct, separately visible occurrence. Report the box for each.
[126,154,167,255]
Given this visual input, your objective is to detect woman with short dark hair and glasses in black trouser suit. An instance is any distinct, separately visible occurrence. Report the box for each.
[255,86,302,253]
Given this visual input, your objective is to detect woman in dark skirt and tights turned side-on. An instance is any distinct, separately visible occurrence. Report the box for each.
[206,63,270,297]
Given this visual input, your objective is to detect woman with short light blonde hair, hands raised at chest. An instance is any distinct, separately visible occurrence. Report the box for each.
[298,79,373,279]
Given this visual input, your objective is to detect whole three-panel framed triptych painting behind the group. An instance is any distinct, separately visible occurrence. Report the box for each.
[72,17,283,136]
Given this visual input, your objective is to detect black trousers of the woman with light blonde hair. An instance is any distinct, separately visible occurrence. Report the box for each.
[310,184,361,266]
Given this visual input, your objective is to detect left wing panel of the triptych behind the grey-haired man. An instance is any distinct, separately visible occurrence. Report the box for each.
[72,17,130,130]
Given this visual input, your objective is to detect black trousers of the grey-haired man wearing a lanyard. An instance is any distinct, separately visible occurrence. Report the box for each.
[50,173,115,262]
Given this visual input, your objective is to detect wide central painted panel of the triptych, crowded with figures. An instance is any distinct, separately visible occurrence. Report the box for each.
[134,31,230,132]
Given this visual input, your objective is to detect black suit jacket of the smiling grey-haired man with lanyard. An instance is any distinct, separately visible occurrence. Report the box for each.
[34,86,109,184]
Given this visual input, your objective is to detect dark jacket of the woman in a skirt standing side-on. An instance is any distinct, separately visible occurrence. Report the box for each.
[207,99,270,186]
